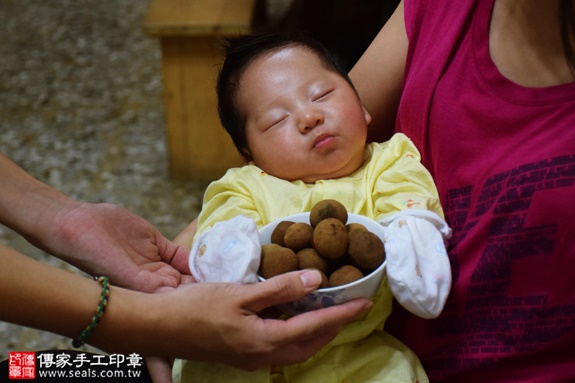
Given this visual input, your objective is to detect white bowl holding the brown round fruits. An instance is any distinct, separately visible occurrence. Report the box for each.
[258,212,386,315]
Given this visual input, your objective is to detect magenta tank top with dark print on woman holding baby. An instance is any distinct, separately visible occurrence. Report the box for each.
[394,0,575,383]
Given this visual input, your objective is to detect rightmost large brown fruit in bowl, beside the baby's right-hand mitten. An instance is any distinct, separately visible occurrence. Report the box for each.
[349,230,385,272]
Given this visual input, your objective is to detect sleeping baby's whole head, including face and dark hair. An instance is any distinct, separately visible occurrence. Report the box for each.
[217,34,371,182]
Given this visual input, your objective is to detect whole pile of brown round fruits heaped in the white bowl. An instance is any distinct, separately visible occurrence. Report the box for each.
[259,199,385,288]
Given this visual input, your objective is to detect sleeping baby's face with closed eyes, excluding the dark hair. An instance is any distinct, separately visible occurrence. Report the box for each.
[237,47,371,182]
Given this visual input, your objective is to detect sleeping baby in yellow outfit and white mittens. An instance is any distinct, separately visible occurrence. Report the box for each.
[174,35,451,383]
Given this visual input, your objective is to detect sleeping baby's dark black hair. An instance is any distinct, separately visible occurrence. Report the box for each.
[217,33,353,160]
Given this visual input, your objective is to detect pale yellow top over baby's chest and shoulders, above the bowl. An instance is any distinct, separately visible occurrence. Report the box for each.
[198,133,443,234]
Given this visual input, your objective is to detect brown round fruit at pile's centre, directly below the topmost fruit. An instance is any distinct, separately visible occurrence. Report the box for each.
[313,218,349,259]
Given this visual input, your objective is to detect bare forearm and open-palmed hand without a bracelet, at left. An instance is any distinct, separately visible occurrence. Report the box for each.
[0,153,194,291]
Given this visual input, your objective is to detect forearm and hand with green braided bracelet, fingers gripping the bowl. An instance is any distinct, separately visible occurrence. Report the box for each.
[0,245,371,369]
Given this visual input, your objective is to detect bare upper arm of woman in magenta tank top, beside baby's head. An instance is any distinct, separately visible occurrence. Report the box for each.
[349,1,408,142]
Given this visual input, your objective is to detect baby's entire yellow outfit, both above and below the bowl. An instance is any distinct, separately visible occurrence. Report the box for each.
[174,133,443,383]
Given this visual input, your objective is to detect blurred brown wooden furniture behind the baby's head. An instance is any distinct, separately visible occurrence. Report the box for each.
[144,0,255,181]
